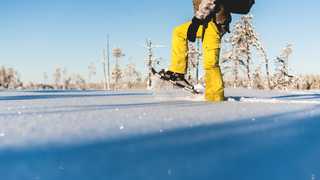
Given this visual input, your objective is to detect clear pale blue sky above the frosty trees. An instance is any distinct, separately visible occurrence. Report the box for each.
[0,0,320,82]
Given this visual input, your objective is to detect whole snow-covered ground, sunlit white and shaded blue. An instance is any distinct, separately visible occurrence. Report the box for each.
[0,89,320,180]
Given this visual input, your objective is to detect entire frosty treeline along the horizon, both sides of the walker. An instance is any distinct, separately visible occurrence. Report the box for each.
[0,15,320,90]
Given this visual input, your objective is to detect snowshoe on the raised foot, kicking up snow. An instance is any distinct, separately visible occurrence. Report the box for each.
[151,68,200,94]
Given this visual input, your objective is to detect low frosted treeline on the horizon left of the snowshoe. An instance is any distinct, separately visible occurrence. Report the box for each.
[0,64,147,90]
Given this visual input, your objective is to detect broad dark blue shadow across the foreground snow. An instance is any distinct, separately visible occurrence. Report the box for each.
[0,106,320,180]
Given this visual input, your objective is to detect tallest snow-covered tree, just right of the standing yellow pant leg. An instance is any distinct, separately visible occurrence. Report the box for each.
[222,15,270,87]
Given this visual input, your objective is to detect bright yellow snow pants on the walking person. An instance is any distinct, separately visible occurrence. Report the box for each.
[169,22,224,102]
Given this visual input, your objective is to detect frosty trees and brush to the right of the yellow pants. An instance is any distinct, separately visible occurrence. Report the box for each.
[221,15,320,90]
